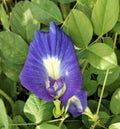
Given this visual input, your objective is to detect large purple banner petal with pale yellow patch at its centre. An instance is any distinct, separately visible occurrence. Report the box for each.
[20,22,82,101]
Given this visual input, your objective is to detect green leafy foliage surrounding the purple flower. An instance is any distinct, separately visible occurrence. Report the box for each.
[0,0,120,129]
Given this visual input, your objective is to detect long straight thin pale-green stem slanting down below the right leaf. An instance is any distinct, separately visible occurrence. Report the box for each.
[96,69,109,115]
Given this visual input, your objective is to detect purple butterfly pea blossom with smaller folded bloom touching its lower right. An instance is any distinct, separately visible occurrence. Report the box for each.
[20,22,87,117]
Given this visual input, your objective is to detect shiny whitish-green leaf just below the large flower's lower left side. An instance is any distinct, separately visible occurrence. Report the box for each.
[24,94,53,123]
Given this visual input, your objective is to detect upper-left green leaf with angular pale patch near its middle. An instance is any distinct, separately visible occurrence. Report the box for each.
[10,1,40,42]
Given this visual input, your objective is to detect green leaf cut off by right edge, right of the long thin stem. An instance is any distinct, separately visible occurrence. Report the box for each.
[110,88,120,114]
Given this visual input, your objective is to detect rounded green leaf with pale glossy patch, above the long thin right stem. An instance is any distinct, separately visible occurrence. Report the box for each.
[87,43,117,70]
